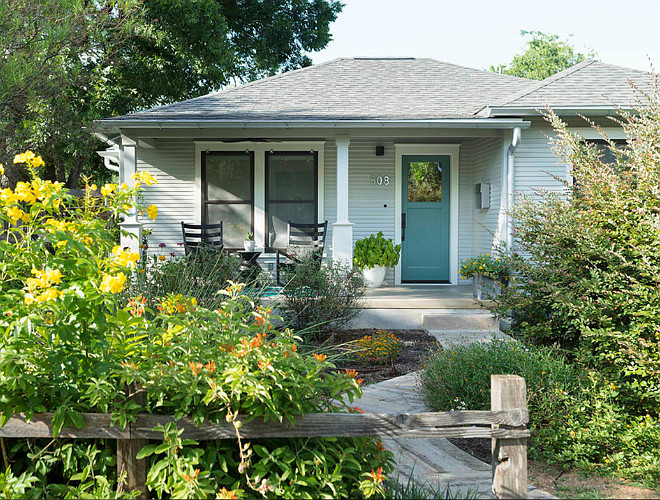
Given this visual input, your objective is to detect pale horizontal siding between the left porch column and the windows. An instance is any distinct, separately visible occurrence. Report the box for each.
[137,140,195,252]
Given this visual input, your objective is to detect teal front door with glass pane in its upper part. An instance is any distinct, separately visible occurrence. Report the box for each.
[401,155,449,283]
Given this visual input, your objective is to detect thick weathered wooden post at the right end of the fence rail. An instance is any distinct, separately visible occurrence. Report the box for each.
[490,375,528,498]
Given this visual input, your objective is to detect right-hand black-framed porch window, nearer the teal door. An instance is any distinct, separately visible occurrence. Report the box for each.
[266,151,318,248]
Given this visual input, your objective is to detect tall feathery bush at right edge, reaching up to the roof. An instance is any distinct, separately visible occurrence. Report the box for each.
[494,91,660,417]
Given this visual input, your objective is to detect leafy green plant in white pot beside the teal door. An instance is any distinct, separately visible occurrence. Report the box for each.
[353,231,401,288]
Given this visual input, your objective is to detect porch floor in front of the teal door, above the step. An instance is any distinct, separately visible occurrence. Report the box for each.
[364,285,488,309]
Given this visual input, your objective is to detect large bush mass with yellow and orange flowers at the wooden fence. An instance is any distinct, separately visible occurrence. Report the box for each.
[0,157,392,498]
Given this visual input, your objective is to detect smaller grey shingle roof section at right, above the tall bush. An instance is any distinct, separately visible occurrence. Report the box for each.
[491,60,652,109]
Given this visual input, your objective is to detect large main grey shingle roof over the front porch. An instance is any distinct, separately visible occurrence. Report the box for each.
[104,58,536,121]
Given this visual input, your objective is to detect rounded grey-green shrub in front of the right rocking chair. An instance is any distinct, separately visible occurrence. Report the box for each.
[282,257,364,336]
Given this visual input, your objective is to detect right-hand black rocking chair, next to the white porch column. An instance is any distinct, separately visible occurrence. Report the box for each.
[275,220,328,285]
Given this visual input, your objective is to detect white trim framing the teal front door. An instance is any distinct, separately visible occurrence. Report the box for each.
[394,144,461,285]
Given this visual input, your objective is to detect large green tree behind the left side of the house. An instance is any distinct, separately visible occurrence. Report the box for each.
[0,0,342,187]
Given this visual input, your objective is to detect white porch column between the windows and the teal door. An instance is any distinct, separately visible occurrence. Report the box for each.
[332,135,353,266]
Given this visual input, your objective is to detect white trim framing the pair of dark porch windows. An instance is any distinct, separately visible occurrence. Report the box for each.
[194,141,325,250]
